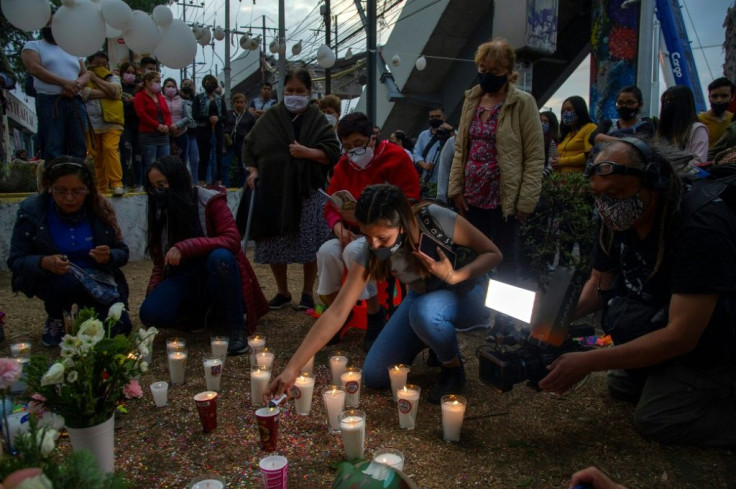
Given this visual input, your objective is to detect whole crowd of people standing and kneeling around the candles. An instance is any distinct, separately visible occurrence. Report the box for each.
[8,33,736,480]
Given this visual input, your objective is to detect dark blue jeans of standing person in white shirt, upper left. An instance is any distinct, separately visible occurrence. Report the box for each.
[36,93,87,161]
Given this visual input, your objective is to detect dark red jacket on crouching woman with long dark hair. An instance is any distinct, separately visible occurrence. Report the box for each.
[146,187,269,334]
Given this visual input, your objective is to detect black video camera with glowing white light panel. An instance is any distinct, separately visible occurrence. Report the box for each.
[476,267,594,392]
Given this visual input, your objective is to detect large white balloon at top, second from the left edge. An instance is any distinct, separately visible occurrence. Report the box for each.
[51,0,107,58]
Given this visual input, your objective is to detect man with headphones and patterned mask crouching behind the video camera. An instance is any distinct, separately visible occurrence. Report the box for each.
[539,138,736,448]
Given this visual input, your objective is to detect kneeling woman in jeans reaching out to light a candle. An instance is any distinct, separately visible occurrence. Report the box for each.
[269,184,501,403]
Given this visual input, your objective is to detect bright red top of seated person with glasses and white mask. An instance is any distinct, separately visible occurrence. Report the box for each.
[324,140,420,229]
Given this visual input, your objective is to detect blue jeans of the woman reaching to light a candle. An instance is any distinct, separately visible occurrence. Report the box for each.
[363,277,488,389]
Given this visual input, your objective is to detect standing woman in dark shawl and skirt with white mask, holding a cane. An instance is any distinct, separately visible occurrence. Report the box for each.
[243,68,340,310]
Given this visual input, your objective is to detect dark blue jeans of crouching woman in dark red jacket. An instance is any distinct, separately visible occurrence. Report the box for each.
[139,248,245,331]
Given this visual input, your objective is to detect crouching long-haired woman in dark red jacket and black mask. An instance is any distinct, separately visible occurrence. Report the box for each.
[140,156,268,355]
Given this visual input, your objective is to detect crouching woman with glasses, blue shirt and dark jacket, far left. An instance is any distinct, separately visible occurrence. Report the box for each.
[8,156,131,346]
